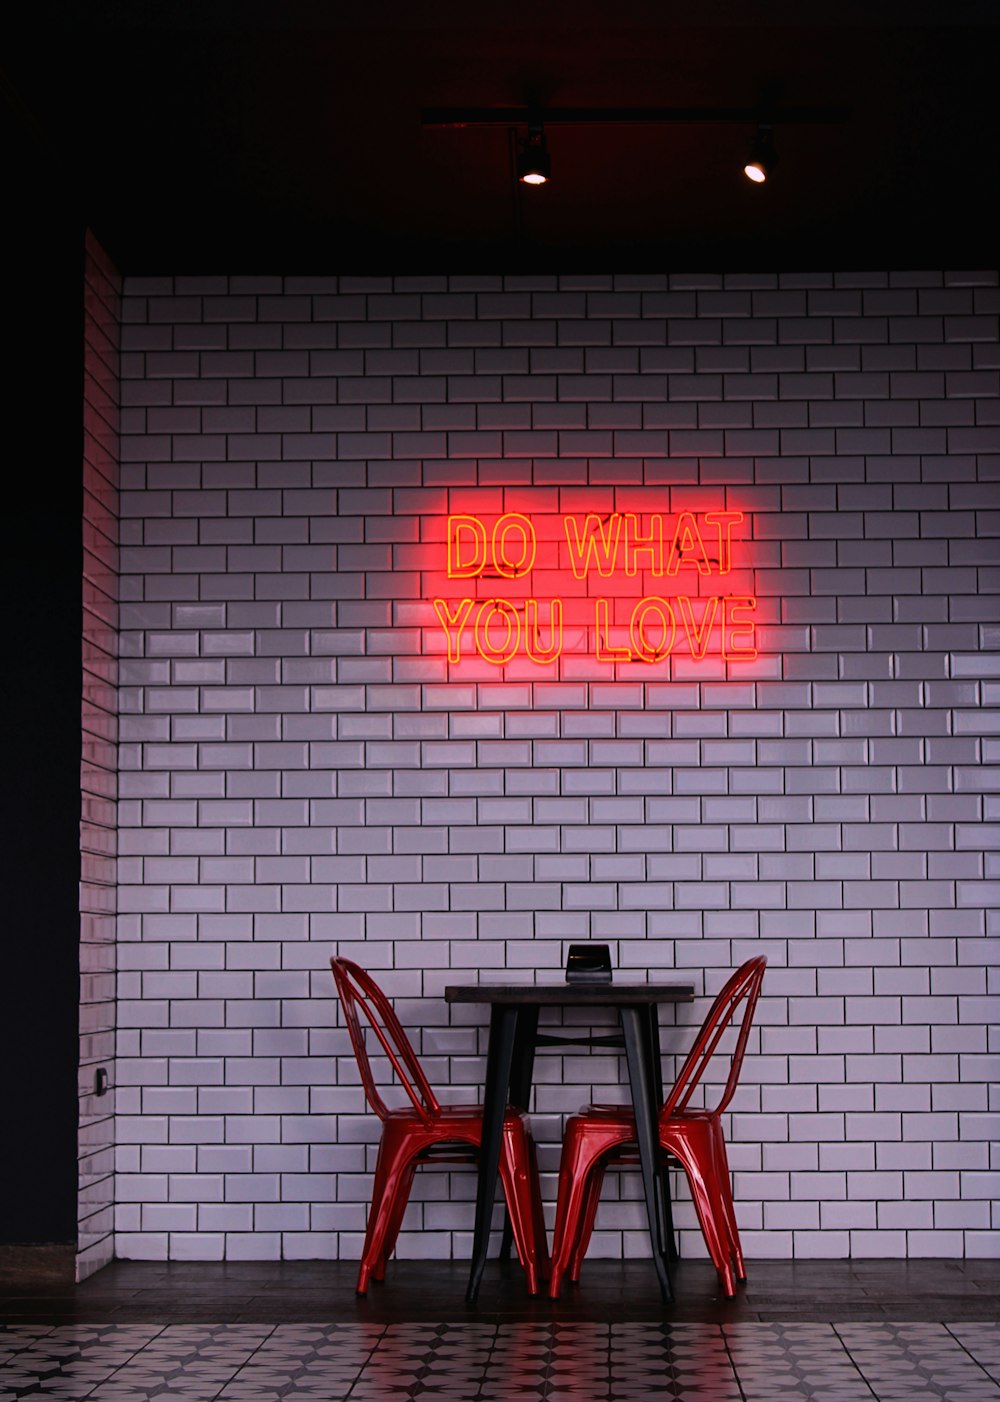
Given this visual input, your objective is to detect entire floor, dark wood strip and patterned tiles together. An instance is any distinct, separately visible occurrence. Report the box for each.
[0,1260,1000,1402]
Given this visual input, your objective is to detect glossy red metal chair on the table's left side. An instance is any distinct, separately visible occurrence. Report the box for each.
[330,959,548,1295]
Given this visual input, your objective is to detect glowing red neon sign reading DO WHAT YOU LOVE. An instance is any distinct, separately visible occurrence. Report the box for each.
[432,510,757,667]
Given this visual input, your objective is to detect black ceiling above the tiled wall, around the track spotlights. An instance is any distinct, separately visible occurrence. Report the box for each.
[3,0,1000,273]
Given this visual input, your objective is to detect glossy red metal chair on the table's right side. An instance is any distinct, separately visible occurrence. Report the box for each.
[548,955,767,1300]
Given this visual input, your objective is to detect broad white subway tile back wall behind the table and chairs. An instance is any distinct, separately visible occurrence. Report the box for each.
[116,272,1000,1259]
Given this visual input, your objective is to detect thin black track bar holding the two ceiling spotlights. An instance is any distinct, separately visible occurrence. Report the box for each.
[421,107,849,126]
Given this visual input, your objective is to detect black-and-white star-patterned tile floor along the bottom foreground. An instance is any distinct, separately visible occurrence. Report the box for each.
[0,1321,1000,1402]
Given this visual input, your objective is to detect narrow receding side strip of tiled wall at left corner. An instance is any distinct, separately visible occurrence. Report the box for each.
[77,234,122,1280]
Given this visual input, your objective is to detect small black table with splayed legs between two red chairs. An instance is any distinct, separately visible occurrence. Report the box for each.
[445,983,694,1304]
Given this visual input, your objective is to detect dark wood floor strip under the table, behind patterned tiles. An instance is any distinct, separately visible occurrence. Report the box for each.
[0,1260,1000,1325]
